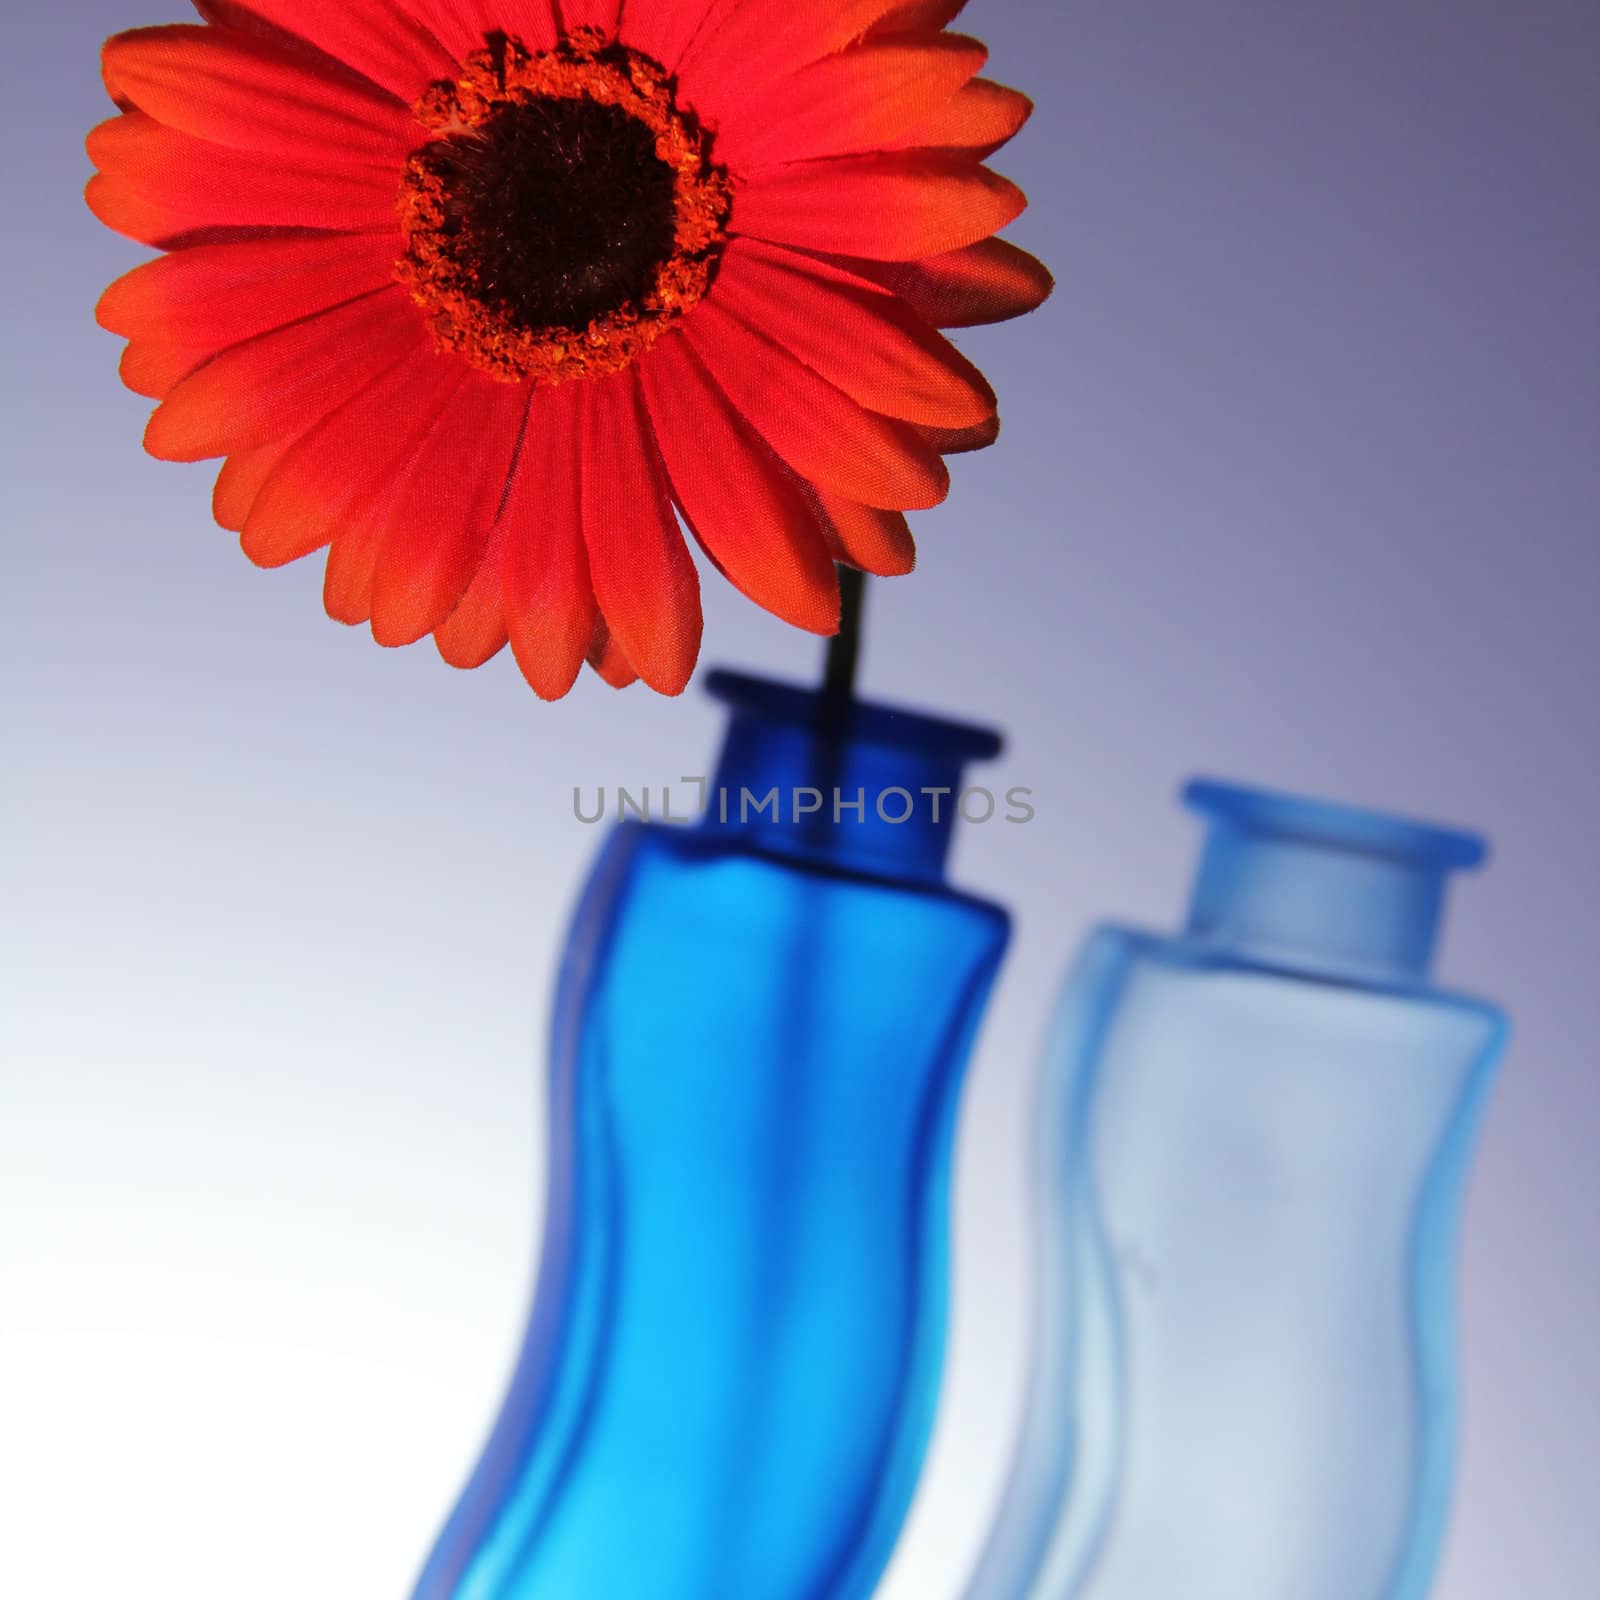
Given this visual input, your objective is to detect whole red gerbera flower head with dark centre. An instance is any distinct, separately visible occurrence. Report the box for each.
[88,0,1050,698]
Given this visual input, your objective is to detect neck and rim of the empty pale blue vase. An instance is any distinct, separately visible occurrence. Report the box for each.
[1184,782,1483,981]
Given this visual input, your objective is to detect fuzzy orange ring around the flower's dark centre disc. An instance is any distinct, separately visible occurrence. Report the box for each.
[395,27,733,384]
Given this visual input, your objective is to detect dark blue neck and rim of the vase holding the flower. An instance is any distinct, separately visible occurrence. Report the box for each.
[706,672,1000,882]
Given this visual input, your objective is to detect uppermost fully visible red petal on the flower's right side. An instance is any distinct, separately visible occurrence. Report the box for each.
[717,34,989,170]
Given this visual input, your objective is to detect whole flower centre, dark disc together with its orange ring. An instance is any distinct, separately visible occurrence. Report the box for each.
[397,29,731,382]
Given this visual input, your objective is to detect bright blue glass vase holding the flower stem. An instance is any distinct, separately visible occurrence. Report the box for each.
[416,674,1008,1600]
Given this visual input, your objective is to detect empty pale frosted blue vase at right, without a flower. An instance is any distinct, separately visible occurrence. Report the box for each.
[970,782,1506,1600]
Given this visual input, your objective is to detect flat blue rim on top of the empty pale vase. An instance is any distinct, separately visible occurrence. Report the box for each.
[1182,778,1488,872]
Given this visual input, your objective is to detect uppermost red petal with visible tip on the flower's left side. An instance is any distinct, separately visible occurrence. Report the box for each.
[101,24,419,173]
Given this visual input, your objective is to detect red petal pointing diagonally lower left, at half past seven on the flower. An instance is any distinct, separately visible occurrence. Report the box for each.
[242,341,462,566]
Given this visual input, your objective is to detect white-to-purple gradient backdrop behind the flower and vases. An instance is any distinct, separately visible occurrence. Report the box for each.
[0,0,1600,1600]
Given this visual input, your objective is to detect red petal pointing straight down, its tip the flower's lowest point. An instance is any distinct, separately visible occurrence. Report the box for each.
[496,382,600,699]
